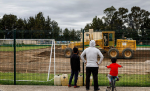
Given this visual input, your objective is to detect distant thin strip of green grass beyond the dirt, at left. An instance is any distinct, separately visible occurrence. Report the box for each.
[0,46,49,51]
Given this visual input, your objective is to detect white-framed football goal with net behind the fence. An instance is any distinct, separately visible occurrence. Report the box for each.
[0,39,55,82]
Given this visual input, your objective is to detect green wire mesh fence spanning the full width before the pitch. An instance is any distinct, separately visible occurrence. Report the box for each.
[0,30,150,86]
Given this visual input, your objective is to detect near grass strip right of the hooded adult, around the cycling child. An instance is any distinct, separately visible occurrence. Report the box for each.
[98,74,150,87]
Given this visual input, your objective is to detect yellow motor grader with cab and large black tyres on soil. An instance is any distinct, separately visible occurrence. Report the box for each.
[62,31,136,59]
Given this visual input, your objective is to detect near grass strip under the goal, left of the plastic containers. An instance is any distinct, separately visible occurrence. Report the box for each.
[0,72,54,85]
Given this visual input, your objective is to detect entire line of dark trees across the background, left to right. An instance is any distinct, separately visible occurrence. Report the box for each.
[0,6,150,42]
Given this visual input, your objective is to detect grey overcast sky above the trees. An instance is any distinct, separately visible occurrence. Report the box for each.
[0,0,150,30]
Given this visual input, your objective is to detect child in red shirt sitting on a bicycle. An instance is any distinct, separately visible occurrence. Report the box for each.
[107,58,122,84]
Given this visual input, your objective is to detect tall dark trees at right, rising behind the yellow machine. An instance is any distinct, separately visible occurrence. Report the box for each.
[84,6,150,44]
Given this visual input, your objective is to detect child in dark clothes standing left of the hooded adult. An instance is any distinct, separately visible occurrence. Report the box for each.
[68,47,80,88]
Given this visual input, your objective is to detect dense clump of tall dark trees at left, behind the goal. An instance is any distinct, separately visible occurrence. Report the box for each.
[0,12,61,40]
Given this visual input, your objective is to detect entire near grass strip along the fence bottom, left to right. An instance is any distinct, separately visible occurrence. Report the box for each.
[0,72,150,87]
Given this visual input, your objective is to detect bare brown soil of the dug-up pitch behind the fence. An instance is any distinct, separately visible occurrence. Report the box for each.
[0,47,150,74]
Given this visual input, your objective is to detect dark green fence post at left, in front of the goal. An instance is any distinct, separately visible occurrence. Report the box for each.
[14,30,16,85]
